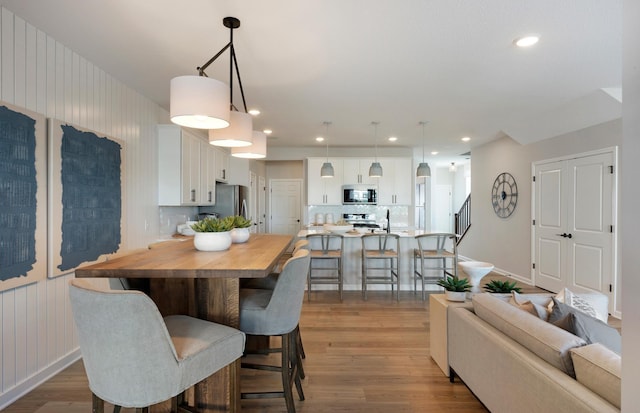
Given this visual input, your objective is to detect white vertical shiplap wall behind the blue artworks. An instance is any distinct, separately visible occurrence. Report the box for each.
[0,8,168,410]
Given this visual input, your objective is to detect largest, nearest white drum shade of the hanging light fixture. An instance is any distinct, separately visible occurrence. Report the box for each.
[170,76,230,129]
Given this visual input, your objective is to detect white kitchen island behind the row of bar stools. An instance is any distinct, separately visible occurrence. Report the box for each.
[297,229,442,291]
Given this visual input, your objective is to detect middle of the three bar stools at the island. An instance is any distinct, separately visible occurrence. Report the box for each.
[361,233,400,301]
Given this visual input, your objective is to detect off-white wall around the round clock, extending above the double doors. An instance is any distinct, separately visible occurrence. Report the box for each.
[459,120,622,286]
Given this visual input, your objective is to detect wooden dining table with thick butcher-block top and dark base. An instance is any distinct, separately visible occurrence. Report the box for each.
[76,234,293,413]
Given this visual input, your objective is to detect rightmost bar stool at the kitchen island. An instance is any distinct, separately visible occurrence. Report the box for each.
[413,232,458,301]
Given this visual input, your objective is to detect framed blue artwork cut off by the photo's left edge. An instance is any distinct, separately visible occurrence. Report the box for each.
[0,102,47,291]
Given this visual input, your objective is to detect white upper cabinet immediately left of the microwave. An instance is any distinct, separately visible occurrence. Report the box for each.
[307,158,342,205]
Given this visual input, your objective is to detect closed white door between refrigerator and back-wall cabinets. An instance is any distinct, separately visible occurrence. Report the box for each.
[269,179,302,235]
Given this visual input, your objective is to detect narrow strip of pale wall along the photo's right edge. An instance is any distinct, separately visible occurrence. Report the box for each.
[620,0,640,406]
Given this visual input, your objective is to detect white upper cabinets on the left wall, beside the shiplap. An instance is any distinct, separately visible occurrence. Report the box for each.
[158,125,215,206]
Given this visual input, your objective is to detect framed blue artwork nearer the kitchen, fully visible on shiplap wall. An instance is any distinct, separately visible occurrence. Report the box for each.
[48,119,124,277]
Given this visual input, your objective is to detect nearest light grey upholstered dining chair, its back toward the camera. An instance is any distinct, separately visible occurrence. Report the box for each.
[69,279,245,412]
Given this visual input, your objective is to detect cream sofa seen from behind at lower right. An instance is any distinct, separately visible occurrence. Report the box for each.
[447,294,621,413]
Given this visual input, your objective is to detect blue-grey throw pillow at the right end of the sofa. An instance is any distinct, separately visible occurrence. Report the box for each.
[549,298,622,354]
